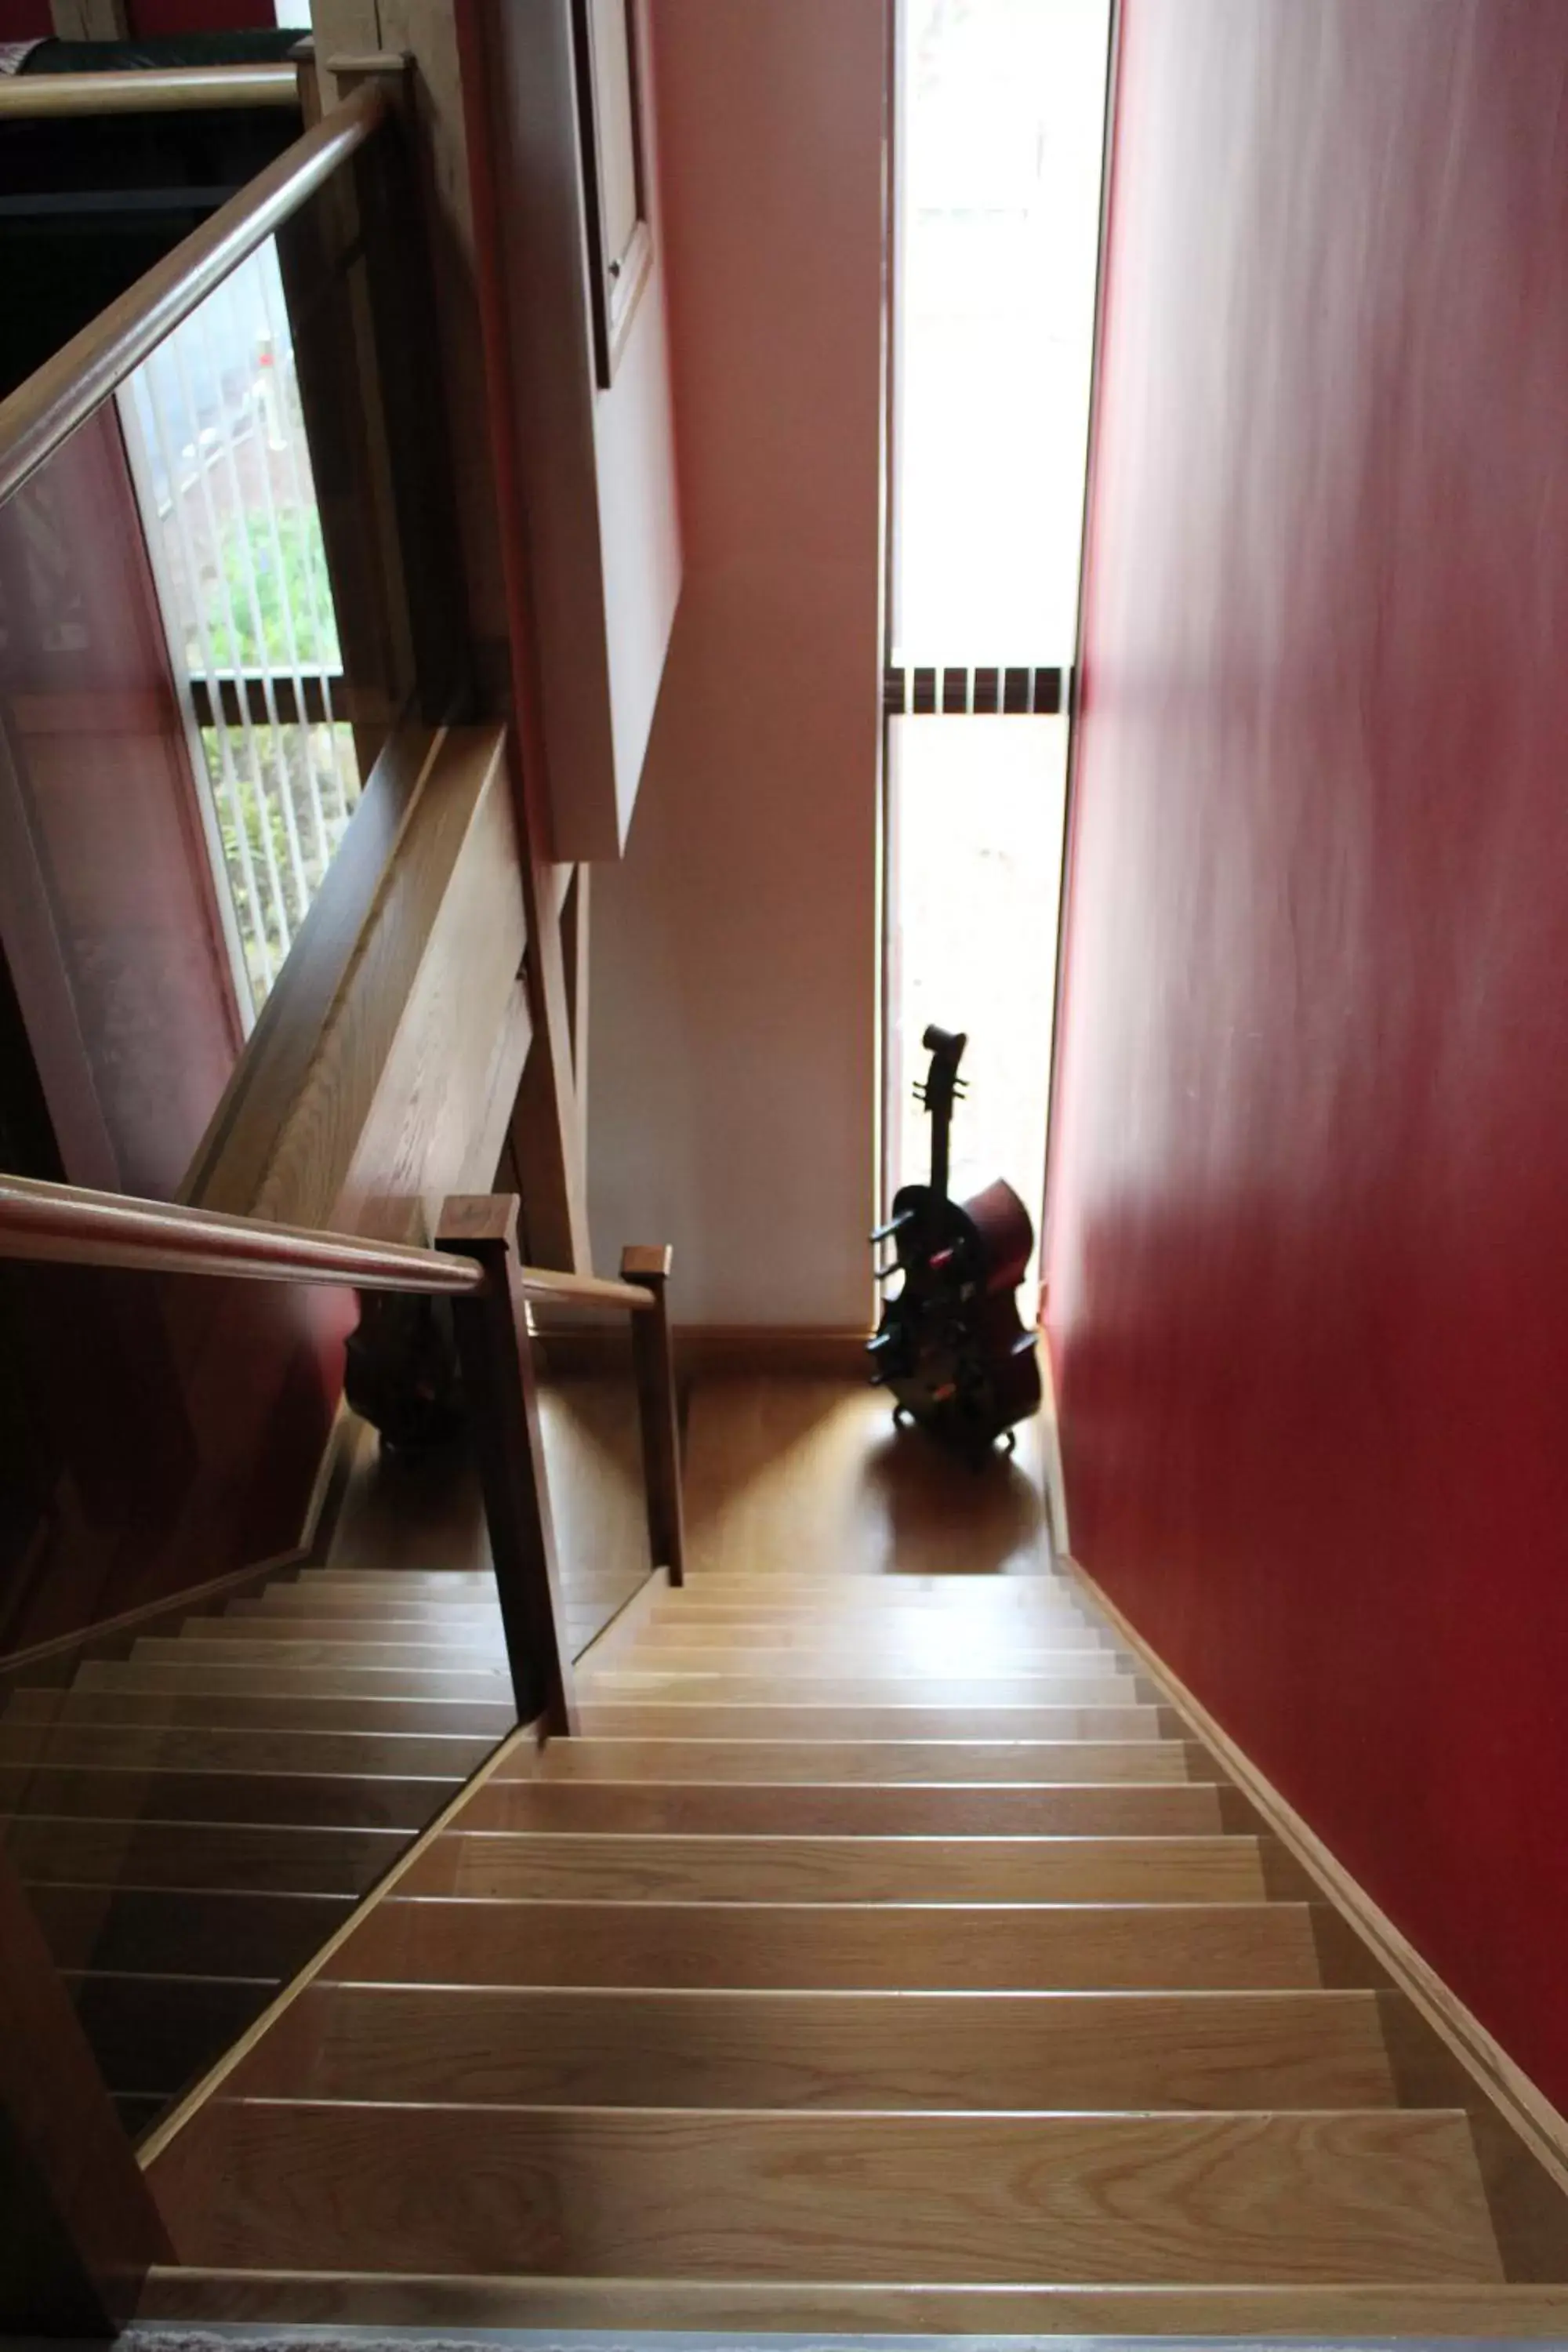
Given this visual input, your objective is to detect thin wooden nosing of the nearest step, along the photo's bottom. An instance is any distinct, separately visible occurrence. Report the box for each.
[127,2270,1568,2352]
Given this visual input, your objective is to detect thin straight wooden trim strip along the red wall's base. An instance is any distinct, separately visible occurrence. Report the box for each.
[1060,1557,1568,2220]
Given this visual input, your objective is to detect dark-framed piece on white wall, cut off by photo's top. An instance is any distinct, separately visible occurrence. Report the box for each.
[572,0,654,390]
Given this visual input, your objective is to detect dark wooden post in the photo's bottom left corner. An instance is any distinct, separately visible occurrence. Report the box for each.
[0,1853,174,2338]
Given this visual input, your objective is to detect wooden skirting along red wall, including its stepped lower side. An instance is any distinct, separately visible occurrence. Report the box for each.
[1062,1555,1568,2281]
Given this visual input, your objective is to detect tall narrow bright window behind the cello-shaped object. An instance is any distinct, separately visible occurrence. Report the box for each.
[884,0,1109,1279]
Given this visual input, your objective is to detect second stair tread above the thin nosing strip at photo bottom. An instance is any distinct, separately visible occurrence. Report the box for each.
[226,1983,1394,2112]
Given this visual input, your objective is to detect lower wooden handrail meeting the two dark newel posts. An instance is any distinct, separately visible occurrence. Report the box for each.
[0,1176,654,1315]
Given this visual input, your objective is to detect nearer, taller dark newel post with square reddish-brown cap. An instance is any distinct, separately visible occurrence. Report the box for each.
[435,1192,579,1733]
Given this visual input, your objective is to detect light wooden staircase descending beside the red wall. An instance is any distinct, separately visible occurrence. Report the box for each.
[131,1573,1568,2336]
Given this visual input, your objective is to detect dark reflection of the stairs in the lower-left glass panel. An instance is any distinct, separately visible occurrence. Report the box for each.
[0,1569,517,2133]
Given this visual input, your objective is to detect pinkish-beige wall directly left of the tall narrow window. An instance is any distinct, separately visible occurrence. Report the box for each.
[590,0,886,1327]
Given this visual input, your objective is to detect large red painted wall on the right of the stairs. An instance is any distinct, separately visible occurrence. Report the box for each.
[1048,0,1568,2105]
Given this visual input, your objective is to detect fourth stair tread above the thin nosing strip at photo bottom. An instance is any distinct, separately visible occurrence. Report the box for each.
[402,1828,1265,1903]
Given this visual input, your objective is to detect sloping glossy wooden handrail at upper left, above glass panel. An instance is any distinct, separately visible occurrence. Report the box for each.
[0,82,390,501]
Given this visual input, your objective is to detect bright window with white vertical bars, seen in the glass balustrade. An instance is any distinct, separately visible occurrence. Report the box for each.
[118,242,360,1023]
